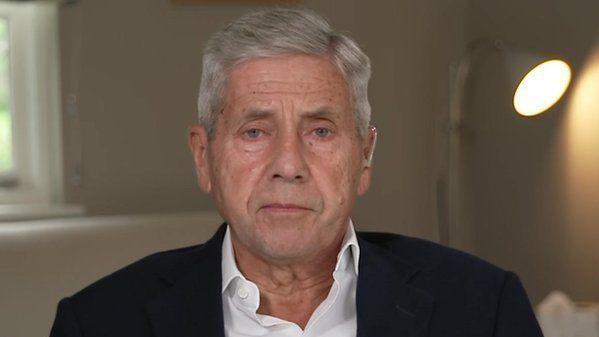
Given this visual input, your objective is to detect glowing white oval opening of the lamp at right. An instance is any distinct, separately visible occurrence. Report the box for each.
[514,59,572,116]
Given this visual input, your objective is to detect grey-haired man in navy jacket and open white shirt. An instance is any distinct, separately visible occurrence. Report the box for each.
[51,9,541,337]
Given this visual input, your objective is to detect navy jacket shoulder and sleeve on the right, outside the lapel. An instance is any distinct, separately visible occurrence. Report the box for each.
[358,233,542,337]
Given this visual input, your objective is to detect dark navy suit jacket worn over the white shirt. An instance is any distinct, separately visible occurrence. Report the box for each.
[50,225,542,337]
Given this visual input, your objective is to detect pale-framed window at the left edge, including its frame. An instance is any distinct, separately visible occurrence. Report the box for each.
[0,1,82,221]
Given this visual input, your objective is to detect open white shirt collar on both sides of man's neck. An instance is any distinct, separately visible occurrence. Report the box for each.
[221,218,360,293]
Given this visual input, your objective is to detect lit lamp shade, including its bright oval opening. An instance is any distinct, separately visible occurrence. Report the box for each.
[504,48,572,117]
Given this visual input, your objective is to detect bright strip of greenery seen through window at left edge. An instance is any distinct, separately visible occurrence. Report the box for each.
[0,19,13,173]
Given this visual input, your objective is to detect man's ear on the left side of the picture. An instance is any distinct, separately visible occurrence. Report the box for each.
[187,125,212,193]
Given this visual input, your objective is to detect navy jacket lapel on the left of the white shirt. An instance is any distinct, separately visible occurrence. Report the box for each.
[146,225,226,337]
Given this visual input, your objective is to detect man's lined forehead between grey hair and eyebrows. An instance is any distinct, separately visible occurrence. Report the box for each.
[225,55,348,104]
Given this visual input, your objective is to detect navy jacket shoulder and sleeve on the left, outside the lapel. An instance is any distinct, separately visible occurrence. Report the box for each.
[55,244,211,337]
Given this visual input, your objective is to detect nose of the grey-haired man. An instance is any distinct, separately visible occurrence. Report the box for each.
[270,132,310,183]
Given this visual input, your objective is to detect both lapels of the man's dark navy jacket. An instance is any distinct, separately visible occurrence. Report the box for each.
[146,224,434,337]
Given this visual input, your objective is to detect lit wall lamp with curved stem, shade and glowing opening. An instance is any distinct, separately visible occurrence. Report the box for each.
[437,39,571,247]
